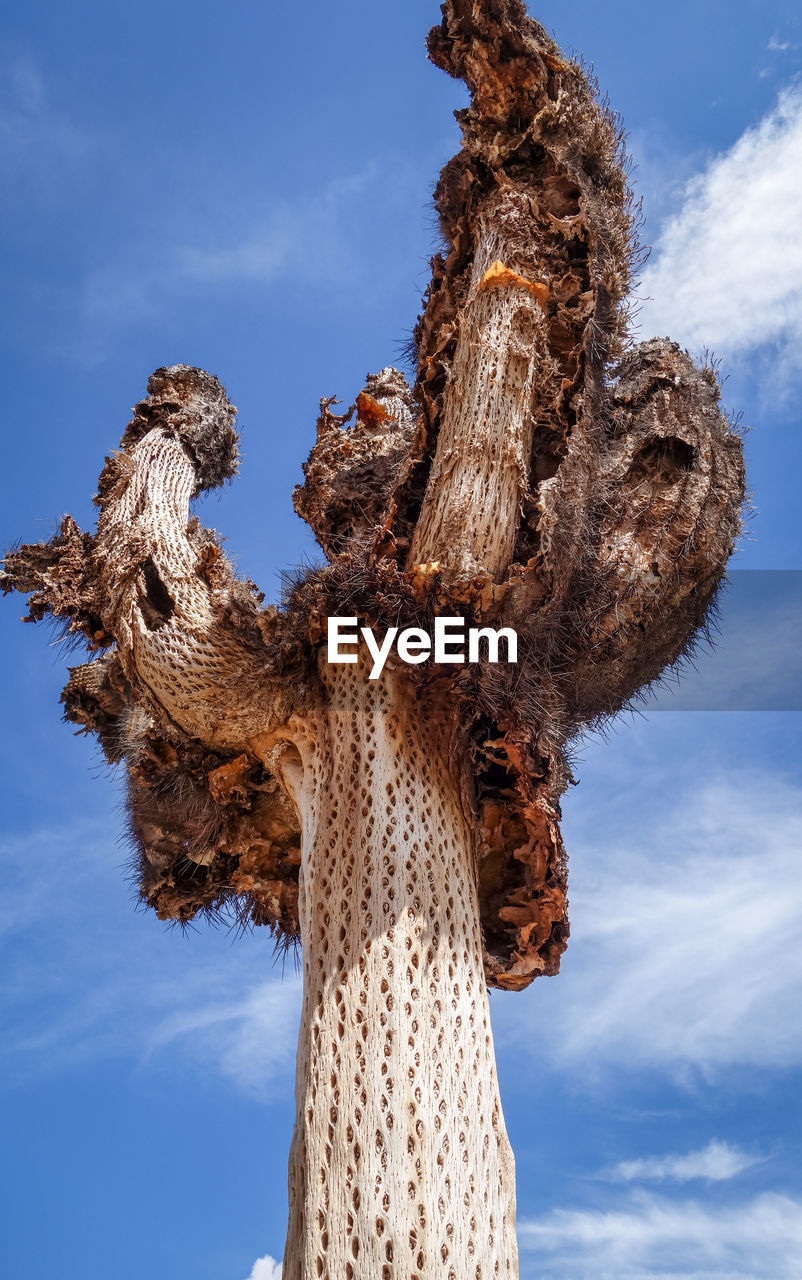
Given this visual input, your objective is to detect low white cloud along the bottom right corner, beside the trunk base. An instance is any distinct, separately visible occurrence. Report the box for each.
[518,1194,802,1280]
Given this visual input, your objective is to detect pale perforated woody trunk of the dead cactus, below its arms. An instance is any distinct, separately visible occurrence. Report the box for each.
[284,667,518,1280]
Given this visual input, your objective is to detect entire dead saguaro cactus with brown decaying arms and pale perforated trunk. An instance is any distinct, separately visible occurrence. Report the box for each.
[3,0,743,1280]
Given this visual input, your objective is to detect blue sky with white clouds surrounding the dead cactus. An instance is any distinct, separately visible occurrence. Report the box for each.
[0,0,802,1280]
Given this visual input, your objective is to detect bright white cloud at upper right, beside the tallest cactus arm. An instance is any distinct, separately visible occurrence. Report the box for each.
[641,88,802,367]
